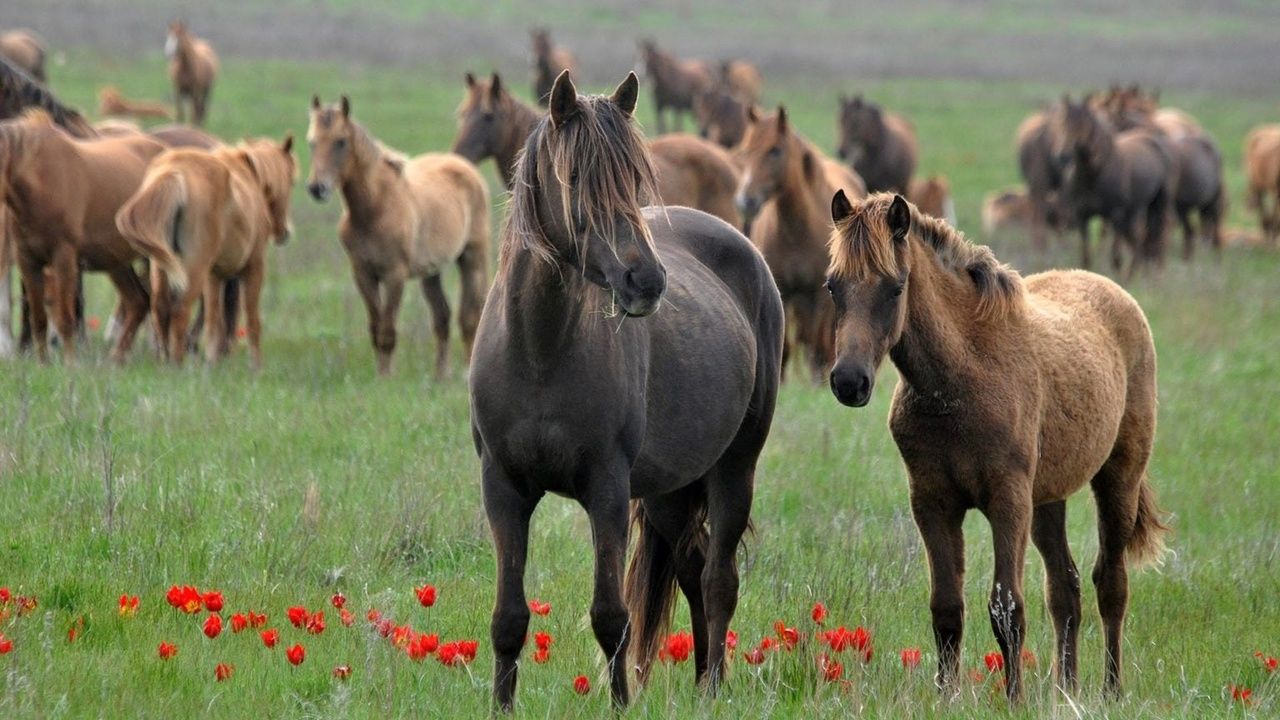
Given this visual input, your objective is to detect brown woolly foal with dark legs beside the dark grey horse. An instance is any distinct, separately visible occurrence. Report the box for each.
[827,192,1166,701]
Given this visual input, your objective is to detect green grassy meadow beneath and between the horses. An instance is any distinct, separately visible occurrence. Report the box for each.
[0,37,1280,717]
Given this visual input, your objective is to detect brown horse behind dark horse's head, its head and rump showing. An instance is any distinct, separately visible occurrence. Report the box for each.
[453,73,740,227]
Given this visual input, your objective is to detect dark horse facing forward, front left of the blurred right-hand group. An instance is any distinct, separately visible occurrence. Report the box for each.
[1052,97,1178,278]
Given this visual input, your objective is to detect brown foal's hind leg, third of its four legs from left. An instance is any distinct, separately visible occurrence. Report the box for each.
[1032,501,1080,692]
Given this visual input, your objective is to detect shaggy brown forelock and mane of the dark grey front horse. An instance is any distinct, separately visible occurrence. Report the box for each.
[499,96,659,263]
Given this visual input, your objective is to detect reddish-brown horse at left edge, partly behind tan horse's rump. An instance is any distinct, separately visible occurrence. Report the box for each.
[0,110,164,361]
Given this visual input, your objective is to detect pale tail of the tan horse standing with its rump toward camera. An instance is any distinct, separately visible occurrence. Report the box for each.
[115,172,187,292]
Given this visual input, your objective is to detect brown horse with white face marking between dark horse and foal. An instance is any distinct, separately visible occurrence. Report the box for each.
[737,106,865,378]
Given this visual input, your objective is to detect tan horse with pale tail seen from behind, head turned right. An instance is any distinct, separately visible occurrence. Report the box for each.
[115,135,297,369]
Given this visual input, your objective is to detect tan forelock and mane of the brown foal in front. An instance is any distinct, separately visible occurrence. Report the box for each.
[828,192,1025,318]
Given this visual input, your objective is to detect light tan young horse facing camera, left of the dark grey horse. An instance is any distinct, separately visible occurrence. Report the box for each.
[307,95,489,378]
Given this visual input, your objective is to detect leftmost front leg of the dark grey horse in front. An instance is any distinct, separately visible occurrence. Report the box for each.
[481,457,539,712]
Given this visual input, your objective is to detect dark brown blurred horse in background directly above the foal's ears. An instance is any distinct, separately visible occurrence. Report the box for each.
[837,95,919,193]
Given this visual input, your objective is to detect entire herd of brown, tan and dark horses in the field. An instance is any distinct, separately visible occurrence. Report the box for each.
[17,19,1280,708]
